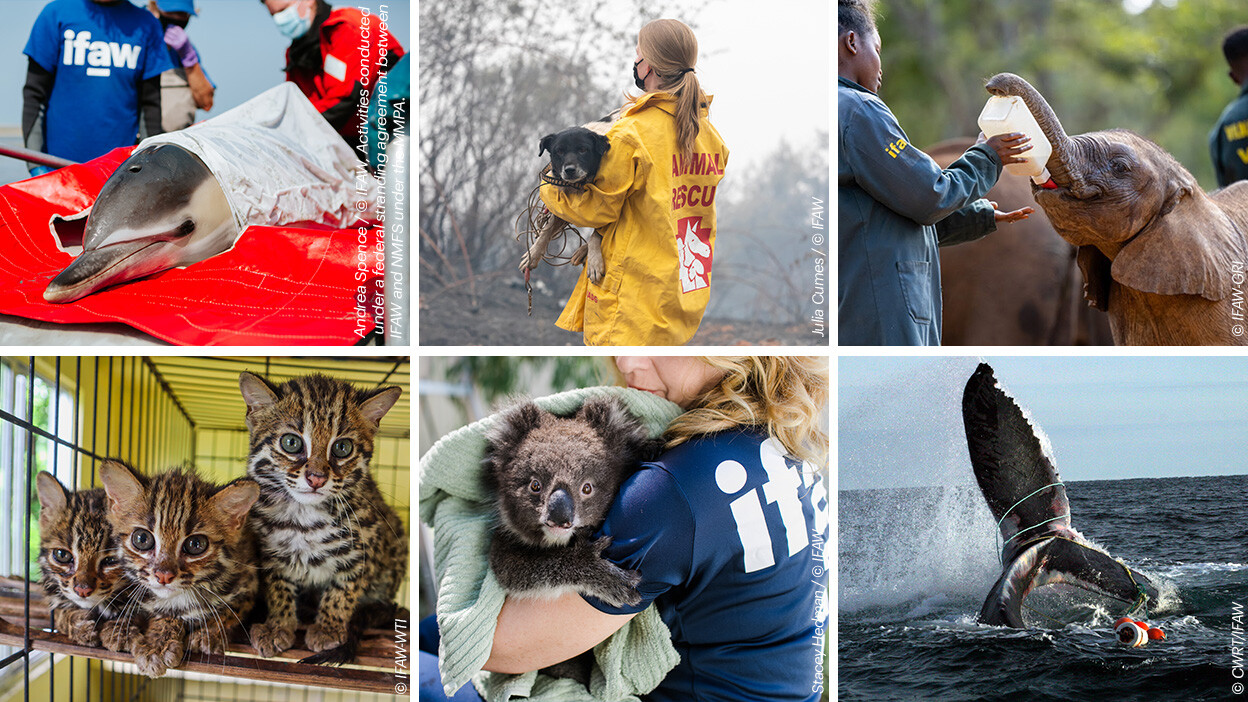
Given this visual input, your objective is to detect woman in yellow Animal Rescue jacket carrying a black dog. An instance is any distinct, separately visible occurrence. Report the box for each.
[542,20,728,346]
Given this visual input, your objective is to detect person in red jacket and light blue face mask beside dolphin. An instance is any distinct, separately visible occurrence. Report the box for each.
[261,0,404,151]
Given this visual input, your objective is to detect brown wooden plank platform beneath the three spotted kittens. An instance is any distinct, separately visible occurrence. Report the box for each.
[0,577,411,695]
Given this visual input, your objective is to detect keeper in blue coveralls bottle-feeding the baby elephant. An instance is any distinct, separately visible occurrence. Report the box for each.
[836,0,1035,346]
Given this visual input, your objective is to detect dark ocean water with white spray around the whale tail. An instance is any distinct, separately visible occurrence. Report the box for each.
[837,475,1248,701]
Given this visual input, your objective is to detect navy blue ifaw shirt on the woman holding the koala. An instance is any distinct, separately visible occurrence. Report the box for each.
[587,431,830,702]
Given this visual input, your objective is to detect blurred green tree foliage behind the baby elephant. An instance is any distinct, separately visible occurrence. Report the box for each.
[879,0,1248,189]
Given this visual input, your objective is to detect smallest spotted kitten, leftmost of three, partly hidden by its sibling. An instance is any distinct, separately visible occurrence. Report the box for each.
[35,472,132,651]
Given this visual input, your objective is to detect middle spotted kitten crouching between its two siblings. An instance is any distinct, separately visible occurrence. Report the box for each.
[100,461,260,677]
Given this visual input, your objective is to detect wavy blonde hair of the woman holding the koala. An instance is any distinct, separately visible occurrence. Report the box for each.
[612,356,830,470]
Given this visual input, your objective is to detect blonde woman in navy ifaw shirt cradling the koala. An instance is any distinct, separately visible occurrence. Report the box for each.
[484,356,830,702]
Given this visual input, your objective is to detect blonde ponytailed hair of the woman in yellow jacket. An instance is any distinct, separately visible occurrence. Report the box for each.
[629,20,706,159]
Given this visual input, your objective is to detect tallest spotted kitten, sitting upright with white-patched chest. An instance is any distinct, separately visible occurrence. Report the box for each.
[238,372,407,663]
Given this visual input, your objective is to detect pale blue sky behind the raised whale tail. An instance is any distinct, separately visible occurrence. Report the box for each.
[837,356,1248,488]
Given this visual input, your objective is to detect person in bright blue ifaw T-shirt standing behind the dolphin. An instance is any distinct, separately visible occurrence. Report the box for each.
[21,0,172,175]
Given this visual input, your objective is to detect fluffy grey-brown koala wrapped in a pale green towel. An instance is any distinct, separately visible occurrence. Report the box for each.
[482,396,661,607]
